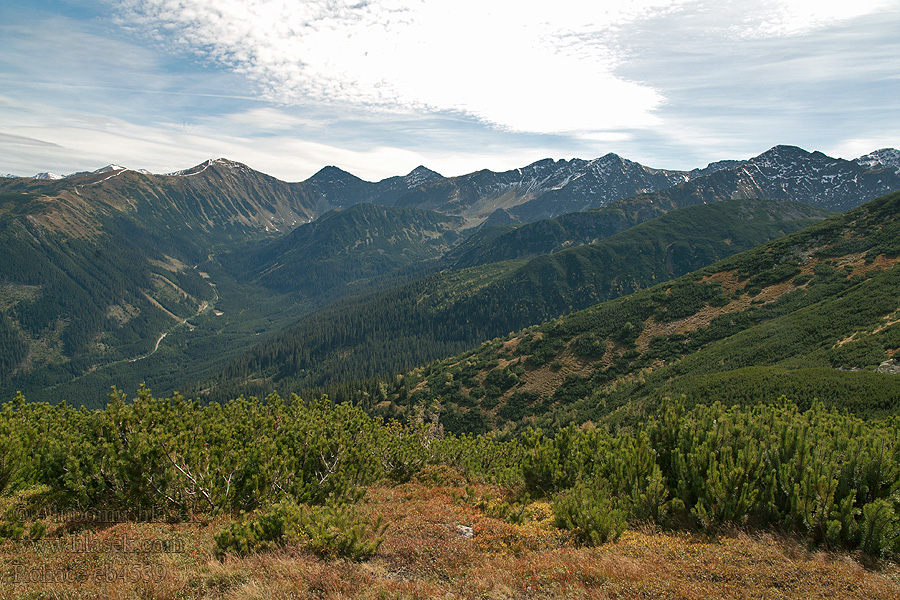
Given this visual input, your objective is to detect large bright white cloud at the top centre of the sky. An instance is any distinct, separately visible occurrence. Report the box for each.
[109,0,688,133]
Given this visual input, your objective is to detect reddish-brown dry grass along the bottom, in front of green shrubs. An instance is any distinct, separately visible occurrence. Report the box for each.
[0,483,900,600]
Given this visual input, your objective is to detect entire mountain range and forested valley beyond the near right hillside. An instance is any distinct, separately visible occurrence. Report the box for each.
[0,146,900,404]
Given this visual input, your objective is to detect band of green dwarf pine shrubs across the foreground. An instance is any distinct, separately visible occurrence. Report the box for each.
[0,389,900,557]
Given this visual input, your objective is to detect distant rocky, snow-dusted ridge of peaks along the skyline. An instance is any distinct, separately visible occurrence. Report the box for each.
[5,145,900,230]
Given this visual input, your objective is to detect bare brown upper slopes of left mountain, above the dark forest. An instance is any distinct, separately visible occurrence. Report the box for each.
[0,159,325,252]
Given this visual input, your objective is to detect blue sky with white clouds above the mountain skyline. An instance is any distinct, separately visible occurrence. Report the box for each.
[0,0,900,181]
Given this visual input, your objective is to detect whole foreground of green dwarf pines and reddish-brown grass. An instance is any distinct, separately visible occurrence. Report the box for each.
[0,389,900,598]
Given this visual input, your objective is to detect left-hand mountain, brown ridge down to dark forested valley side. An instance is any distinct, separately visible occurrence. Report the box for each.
[0,160,326,387]
